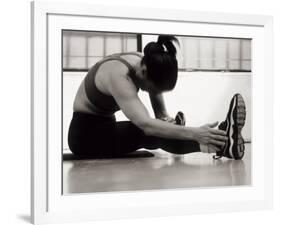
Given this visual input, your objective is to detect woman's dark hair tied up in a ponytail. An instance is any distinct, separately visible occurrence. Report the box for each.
[141,35,179,90]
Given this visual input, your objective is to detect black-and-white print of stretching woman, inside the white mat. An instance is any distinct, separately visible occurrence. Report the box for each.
[61,29,250,194]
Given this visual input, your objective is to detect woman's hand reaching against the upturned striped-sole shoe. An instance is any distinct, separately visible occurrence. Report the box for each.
[194,122,228,147]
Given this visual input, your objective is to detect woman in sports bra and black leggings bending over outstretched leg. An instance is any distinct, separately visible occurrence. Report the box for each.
[68,35,246,159]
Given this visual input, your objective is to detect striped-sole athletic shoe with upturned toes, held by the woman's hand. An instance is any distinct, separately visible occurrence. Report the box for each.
[213,94,246,159]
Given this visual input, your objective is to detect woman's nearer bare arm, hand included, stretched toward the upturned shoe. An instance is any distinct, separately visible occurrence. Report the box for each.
[109,69,227,146]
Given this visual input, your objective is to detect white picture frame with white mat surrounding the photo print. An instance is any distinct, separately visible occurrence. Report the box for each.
[31,1,273,224]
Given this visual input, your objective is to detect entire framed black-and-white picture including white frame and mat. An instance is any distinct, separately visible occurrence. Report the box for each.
[27,1,276,224]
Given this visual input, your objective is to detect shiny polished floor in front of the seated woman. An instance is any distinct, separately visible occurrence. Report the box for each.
[63,144,251,194]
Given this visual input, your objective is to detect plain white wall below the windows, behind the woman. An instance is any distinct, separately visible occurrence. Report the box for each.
[63,72,251,149]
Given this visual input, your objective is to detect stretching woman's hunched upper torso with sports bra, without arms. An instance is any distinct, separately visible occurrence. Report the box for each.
[73,52,142,116]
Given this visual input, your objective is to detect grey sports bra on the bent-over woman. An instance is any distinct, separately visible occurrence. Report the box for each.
[84,52,142,116]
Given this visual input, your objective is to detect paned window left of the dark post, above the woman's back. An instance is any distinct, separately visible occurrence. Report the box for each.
[63,30,141,71]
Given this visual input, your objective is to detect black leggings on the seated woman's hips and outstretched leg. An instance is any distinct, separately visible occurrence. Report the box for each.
[68,112,200,158]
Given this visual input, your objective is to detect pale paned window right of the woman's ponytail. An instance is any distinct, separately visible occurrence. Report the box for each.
[178,37,251,72]
